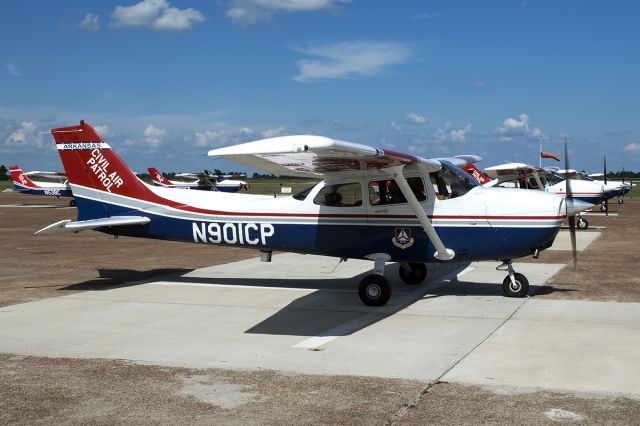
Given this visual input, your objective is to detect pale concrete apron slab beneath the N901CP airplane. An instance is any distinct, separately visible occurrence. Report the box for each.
[0,231,640,398]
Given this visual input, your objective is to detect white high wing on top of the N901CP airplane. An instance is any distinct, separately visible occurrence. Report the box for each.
[209,135,440,178]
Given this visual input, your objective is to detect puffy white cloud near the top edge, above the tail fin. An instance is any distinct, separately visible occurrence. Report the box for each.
[111,0,204,31]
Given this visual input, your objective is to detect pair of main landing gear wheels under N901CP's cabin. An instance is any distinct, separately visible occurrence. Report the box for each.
[358,253,427,306]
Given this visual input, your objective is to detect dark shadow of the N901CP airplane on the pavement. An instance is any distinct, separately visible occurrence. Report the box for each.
[53,263,577,337]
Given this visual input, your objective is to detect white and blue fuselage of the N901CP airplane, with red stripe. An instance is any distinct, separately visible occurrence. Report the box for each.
[73,177,564,262]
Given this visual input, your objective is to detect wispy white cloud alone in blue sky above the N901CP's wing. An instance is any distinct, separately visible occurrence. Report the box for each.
[293,42,412,82]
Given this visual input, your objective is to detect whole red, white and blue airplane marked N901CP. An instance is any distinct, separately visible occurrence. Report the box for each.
[36,121,574,306]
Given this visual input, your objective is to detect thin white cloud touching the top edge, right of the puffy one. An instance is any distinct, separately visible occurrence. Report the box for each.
[226,0,350,26]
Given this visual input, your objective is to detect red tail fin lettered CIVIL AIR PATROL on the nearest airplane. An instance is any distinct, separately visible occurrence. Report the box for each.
[51,121,149,198]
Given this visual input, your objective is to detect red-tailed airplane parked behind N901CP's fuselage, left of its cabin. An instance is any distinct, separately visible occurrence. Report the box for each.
[147,167,250,192]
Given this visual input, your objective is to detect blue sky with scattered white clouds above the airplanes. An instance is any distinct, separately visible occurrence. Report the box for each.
[0,0,640,172]
